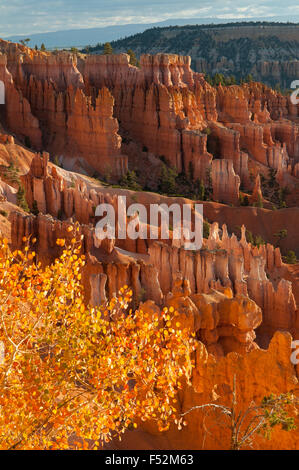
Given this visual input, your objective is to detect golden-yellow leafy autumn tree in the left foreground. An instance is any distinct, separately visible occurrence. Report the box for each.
[0,233,194,449]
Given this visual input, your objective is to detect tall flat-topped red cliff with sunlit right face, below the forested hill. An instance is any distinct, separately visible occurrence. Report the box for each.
[79,54,217,179]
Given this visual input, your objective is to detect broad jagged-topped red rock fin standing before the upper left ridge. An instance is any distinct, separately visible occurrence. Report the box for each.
[21,80,127,177]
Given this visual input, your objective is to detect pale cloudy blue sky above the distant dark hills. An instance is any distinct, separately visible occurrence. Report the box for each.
[0,0,299,37]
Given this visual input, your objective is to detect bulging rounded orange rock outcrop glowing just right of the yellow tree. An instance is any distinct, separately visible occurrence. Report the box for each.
[166,276,262,356]
